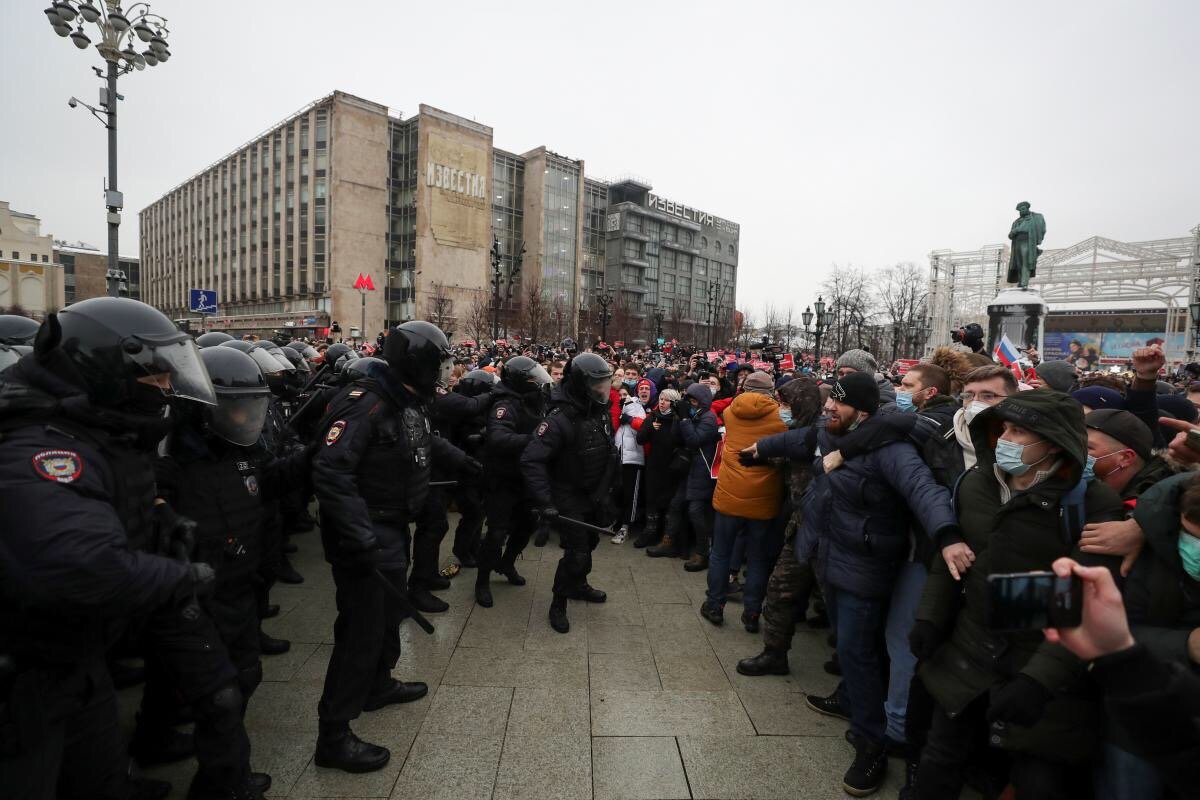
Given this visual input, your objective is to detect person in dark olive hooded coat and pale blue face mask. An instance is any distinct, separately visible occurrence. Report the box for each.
[910,390,1122,800]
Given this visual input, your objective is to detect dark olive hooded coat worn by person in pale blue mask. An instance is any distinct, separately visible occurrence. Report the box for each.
[916,390,1123,760]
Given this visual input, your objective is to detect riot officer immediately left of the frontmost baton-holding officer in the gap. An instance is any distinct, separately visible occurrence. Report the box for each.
[475,355,551,608]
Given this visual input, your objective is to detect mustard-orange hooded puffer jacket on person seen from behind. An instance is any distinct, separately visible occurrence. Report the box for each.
[713,391,787,519]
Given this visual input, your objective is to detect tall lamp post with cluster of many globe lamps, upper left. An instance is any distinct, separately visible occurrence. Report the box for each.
[44,0,170,297]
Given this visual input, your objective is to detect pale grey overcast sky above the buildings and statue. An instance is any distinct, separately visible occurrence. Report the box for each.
[0,0,1200,308]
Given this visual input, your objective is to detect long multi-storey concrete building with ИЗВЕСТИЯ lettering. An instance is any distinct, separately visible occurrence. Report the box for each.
[140,91,739,339]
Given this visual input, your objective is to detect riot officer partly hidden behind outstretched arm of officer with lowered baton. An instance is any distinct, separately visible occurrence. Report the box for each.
[408,362,494,613]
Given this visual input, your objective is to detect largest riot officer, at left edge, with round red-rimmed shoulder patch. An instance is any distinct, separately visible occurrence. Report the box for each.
[0,297,216,800]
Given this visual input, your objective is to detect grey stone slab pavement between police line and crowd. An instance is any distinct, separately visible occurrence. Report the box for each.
[121,519,904,800]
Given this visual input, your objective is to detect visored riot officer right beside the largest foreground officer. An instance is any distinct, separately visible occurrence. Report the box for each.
[133,347,280,798]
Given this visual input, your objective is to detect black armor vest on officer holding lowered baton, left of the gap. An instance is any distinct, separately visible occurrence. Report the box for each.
[355,381,433,519]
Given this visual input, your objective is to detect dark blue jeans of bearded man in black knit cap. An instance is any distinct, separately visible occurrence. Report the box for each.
[824,585,888,745]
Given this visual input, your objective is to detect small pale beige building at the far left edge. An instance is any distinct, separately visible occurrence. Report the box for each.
[0,200,65,318]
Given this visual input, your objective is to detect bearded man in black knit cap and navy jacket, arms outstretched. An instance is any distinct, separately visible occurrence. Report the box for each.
[750,372,959,796]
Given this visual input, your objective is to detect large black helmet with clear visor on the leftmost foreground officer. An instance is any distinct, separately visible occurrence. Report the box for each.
[35,297,216,416]
